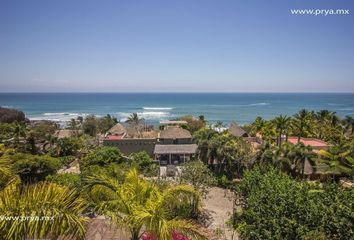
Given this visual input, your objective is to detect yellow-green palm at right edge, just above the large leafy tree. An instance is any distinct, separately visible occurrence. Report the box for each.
[316,146,353,174]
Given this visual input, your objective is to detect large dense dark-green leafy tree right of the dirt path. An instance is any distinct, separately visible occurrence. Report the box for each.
[234,168,354,240]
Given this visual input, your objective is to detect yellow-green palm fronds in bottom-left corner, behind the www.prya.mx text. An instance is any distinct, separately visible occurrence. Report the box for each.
[0,182,87,239]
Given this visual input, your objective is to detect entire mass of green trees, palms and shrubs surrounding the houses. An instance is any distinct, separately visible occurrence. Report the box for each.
[0,110,354,240]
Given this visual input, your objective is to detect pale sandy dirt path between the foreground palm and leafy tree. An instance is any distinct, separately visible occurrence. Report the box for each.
[203,187,238,240]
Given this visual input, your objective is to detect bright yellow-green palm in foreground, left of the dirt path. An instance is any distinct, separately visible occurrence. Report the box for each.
[85,170,203,240]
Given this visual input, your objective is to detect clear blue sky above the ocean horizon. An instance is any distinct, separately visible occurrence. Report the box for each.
[0,0,354,92]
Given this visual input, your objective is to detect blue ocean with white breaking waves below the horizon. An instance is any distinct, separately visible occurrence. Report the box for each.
[0,93,354,125]
